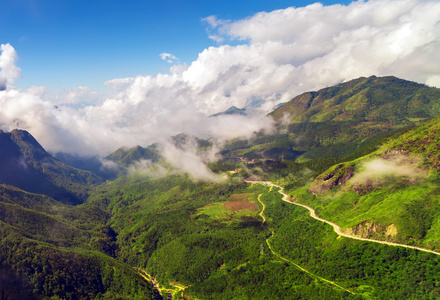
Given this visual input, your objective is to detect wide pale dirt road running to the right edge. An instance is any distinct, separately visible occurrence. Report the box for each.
[246,181,440,255]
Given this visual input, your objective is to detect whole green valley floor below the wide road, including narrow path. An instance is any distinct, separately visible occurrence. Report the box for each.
[90,174,440,299]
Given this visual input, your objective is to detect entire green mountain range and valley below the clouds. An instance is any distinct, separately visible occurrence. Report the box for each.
[0,76,440,299]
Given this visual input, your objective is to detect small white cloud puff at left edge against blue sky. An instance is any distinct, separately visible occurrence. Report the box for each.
[0,44,21,91]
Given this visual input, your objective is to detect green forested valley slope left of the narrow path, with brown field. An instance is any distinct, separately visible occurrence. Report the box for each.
[90,174,360,299]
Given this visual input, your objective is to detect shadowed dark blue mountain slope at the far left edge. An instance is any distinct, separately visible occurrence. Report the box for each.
[0,130,101,204]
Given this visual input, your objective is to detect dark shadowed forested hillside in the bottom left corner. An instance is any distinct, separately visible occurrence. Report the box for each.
[0,186,159,299]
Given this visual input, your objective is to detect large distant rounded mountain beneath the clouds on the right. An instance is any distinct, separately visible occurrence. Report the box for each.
[224,76,440,161]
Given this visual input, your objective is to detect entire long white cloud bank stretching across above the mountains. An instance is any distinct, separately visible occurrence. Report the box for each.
[0,0,440,173]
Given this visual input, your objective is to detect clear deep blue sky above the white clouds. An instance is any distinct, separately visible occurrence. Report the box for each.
[0,0,349,90]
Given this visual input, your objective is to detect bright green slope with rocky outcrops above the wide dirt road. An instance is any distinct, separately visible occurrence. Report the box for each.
[292,118,440,250]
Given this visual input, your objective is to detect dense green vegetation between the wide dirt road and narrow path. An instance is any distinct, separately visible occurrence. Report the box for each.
[267,188,440,299]
